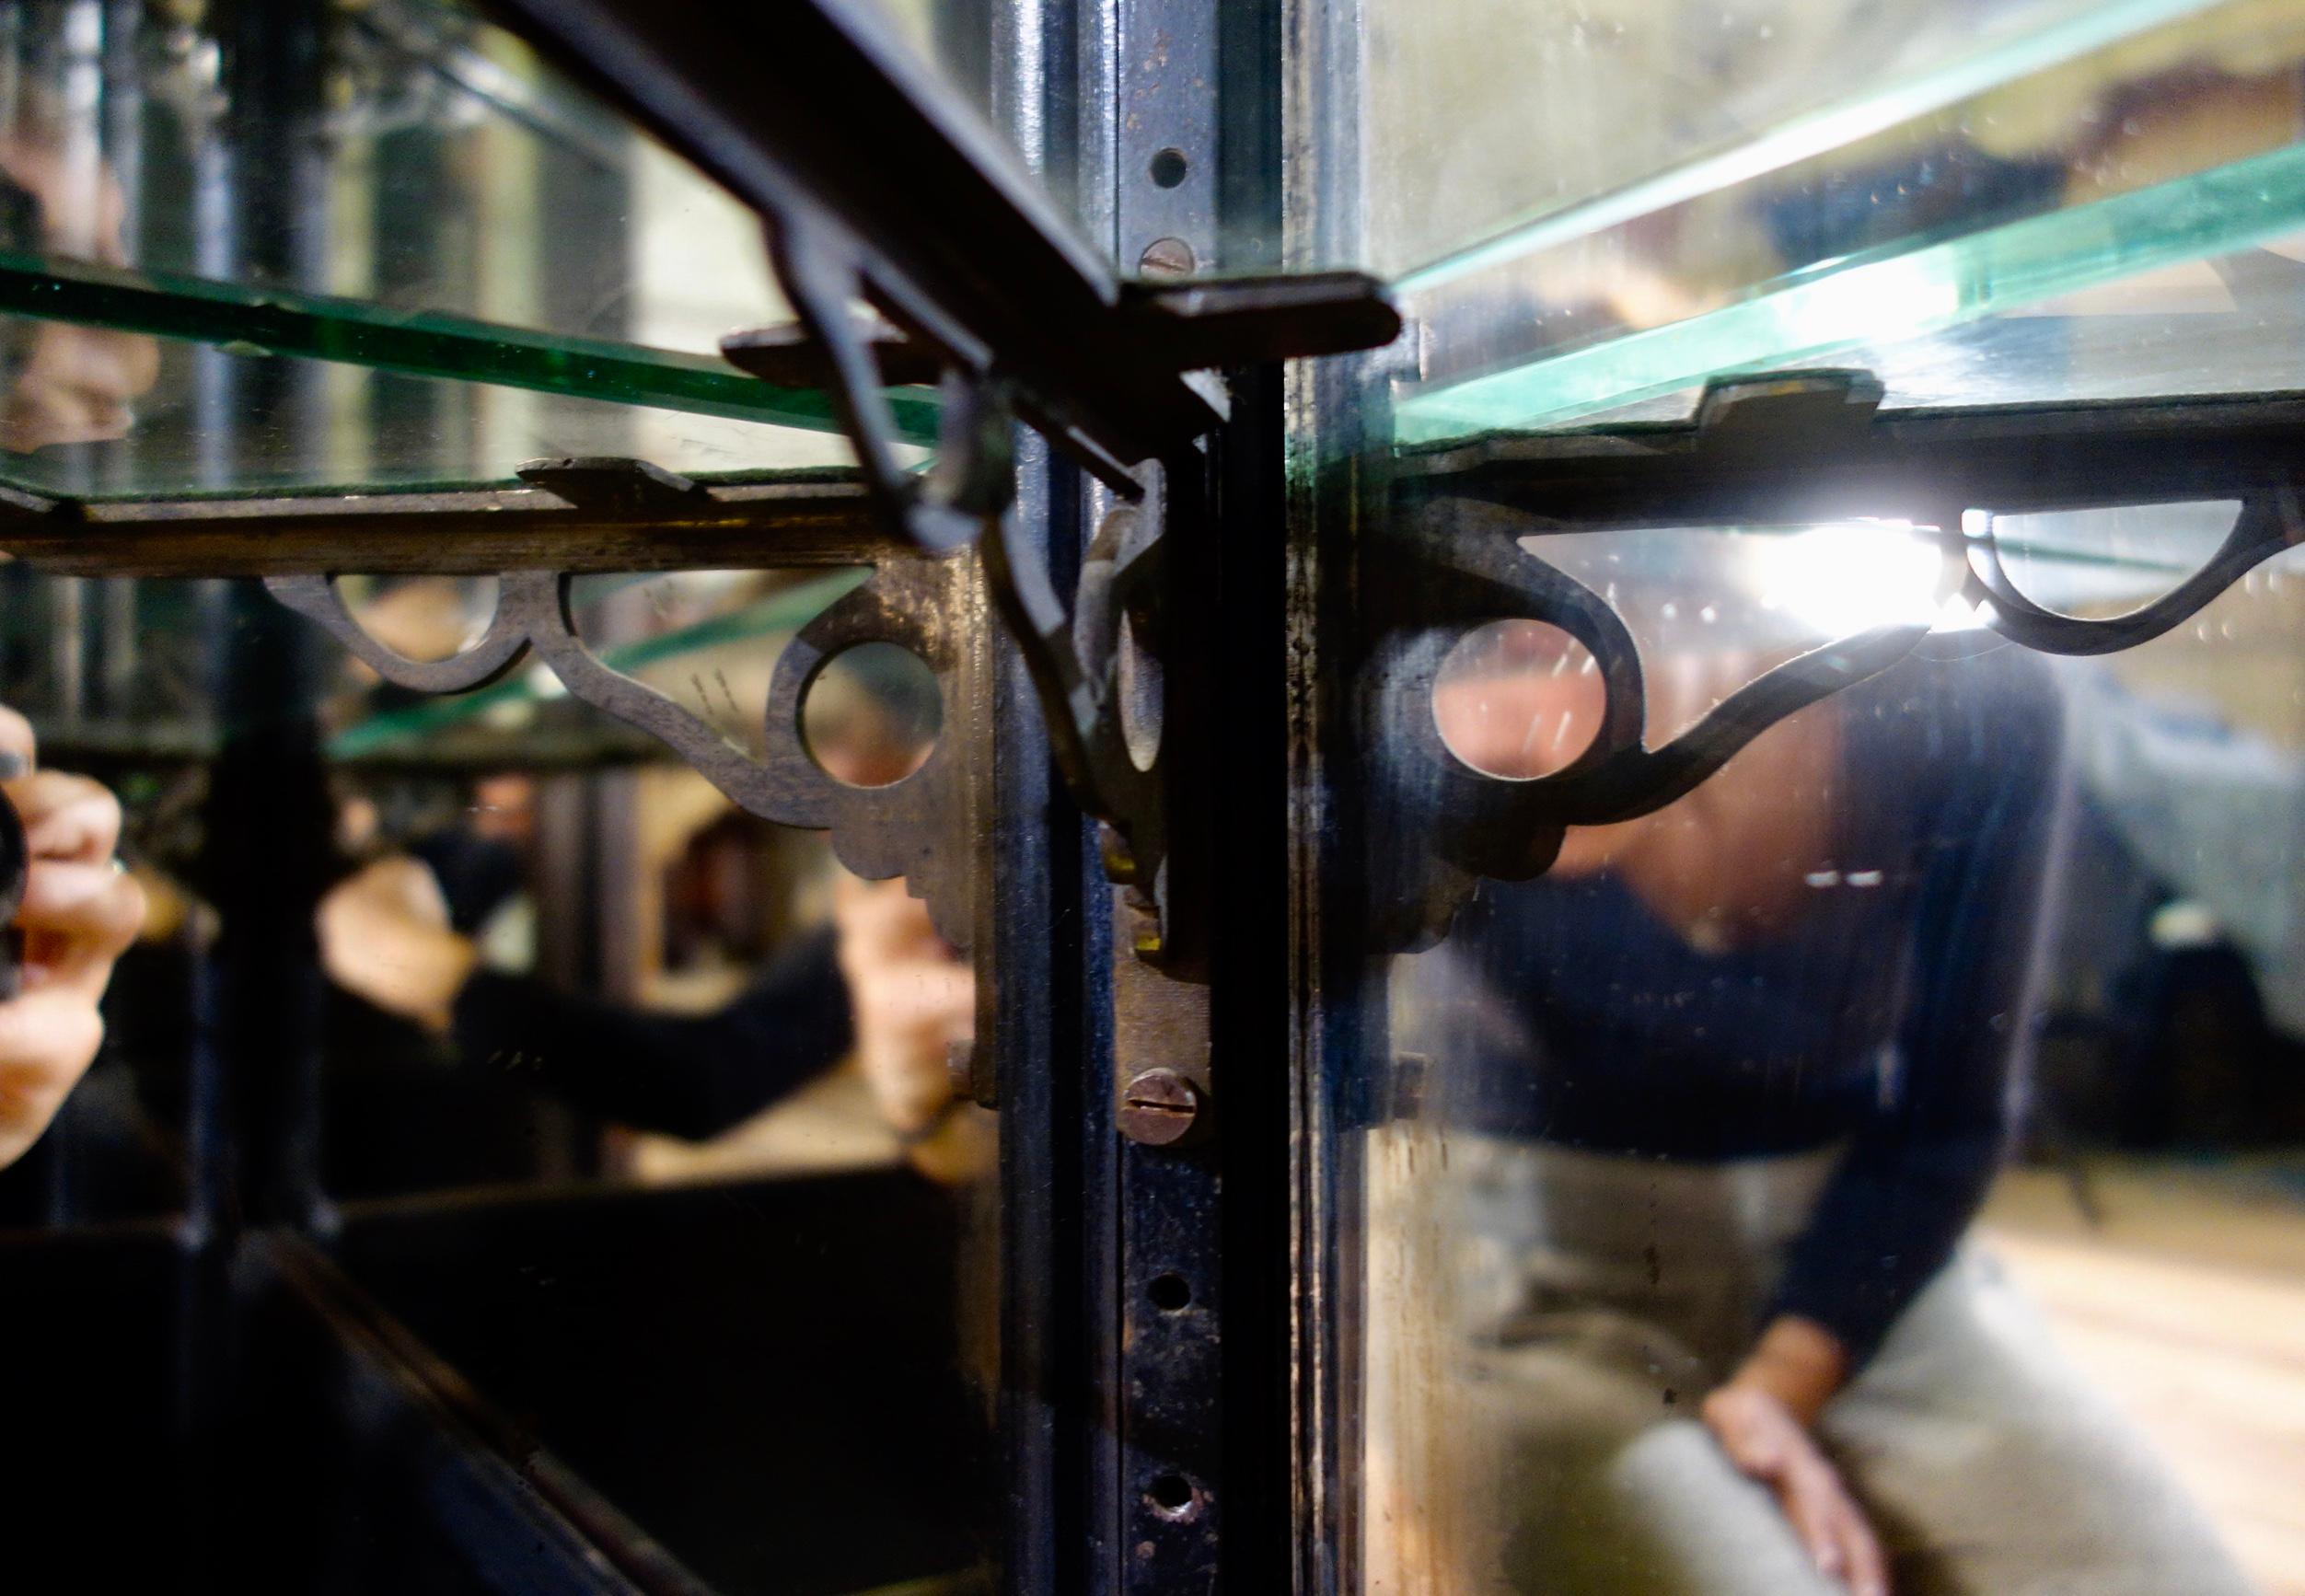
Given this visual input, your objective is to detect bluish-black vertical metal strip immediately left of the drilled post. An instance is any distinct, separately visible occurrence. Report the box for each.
[986,0,1116,1596]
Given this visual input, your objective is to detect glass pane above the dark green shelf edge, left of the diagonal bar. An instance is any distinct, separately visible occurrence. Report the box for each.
[0,0,782,355]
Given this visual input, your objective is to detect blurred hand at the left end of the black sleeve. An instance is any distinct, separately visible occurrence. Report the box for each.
[319,853,480,1031]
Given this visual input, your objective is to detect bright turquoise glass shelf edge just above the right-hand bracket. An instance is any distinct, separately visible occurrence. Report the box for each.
[1395,145,2305,445]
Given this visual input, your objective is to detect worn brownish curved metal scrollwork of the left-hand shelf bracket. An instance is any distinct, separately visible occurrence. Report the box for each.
[265,561,970,945]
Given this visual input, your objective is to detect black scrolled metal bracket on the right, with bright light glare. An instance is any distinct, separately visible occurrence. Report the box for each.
[1362,371,2305,945]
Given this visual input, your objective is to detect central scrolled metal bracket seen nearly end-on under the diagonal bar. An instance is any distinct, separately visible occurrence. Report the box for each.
[747,213,1399,971]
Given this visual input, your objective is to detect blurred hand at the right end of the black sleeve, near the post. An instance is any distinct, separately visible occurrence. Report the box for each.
[832,874,978,1137]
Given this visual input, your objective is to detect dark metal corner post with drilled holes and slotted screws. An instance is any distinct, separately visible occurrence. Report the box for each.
[1081,0,1303,1596]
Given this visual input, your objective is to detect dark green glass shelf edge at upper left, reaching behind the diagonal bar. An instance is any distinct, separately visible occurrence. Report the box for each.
[0,251,938,443]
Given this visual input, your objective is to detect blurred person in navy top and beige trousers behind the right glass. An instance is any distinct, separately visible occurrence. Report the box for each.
[1372,609,2247,1596]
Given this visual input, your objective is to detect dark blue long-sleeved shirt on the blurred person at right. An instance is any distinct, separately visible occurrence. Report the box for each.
[1419,651,2058,1360]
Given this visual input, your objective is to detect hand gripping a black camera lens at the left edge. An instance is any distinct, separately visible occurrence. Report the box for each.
[0,708,145,1167]
